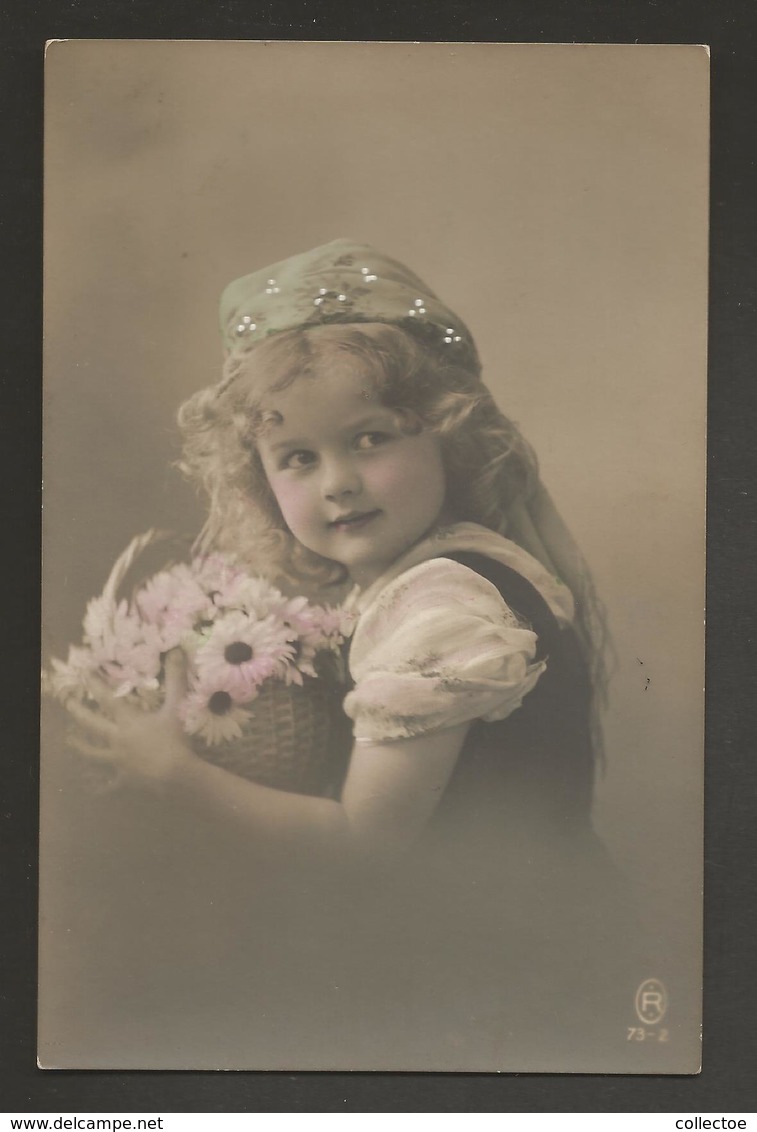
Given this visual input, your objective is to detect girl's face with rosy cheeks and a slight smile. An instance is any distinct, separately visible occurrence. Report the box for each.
[258,365,445,586]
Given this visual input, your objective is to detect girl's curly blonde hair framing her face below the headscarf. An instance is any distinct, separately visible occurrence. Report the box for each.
[179,323,537,585]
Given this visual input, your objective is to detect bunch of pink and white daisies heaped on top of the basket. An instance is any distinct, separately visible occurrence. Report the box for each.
[43,539,355,743]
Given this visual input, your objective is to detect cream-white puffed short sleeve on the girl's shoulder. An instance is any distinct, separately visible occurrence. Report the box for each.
[344,558,545,743]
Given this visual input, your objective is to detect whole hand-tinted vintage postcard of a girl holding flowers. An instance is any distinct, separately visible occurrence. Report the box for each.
[38,40,709,1074]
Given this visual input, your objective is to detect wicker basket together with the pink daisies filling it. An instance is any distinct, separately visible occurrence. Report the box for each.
[43,531,353,794]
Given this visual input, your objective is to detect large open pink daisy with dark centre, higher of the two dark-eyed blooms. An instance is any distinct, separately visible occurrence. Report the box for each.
[195,612,292,703]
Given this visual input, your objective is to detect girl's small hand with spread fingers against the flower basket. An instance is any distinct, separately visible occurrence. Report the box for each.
[63,649,196,789]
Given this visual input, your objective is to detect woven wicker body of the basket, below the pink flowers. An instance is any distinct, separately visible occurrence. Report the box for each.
[195,678,352,796]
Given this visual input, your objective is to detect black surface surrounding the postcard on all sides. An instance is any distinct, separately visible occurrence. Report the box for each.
[0,0,757,1113]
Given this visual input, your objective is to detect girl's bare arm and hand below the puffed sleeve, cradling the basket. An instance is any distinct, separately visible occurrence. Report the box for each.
[69,652,467,867]
